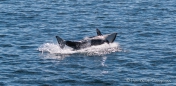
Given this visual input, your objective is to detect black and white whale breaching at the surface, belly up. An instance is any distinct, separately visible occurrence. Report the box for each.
[56,29,117,50]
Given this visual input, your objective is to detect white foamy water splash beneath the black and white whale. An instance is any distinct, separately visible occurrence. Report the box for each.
[38,43,121,56]
